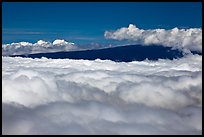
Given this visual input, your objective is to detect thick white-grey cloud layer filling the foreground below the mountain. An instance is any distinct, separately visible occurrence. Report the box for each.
[2,53,202,134]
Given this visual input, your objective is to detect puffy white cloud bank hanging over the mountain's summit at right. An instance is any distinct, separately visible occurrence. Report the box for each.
[104,24,202,52]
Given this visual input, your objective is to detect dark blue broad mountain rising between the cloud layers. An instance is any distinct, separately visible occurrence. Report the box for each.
[12,45,183,62]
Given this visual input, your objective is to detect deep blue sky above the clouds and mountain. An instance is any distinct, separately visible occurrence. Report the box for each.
[2,2,202,44]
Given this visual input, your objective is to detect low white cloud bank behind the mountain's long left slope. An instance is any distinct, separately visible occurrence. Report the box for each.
[2,39,78,55]
